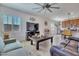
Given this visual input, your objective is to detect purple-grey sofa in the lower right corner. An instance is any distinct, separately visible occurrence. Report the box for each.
[50,36,79,56]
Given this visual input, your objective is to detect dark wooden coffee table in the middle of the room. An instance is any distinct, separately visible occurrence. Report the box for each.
[30,36,53,50]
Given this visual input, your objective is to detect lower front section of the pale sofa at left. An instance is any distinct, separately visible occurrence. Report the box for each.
[1,48,26,56]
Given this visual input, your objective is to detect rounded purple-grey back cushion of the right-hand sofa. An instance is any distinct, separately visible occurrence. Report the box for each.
[50,46,78,56]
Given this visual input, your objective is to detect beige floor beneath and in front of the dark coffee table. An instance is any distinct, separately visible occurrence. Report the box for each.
[22,40,51,56]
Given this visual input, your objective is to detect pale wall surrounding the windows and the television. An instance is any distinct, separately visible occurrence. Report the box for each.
[0,7,50,40]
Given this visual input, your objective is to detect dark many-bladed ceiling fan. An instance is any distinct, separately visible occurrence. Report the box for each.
[33,3,60,12]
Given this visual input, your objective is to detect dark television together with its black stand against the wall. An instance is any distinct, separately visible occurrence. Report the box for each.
[26,22,39,41]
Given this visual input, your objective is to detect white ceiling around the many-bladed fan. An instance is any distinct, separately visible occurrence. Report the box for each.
[2,3,79,20]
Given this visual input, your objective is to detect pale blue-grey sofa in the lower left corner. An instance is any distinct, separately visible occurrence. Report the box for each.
[0,37,26,56]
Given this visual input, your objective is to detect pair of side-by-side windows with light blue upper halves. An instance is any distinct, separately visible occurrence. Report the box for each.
[3,15,21,32]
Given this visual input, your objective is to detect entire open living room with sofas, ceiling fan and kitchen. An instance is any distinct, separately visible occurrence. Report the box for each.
[0,3,79,56]
